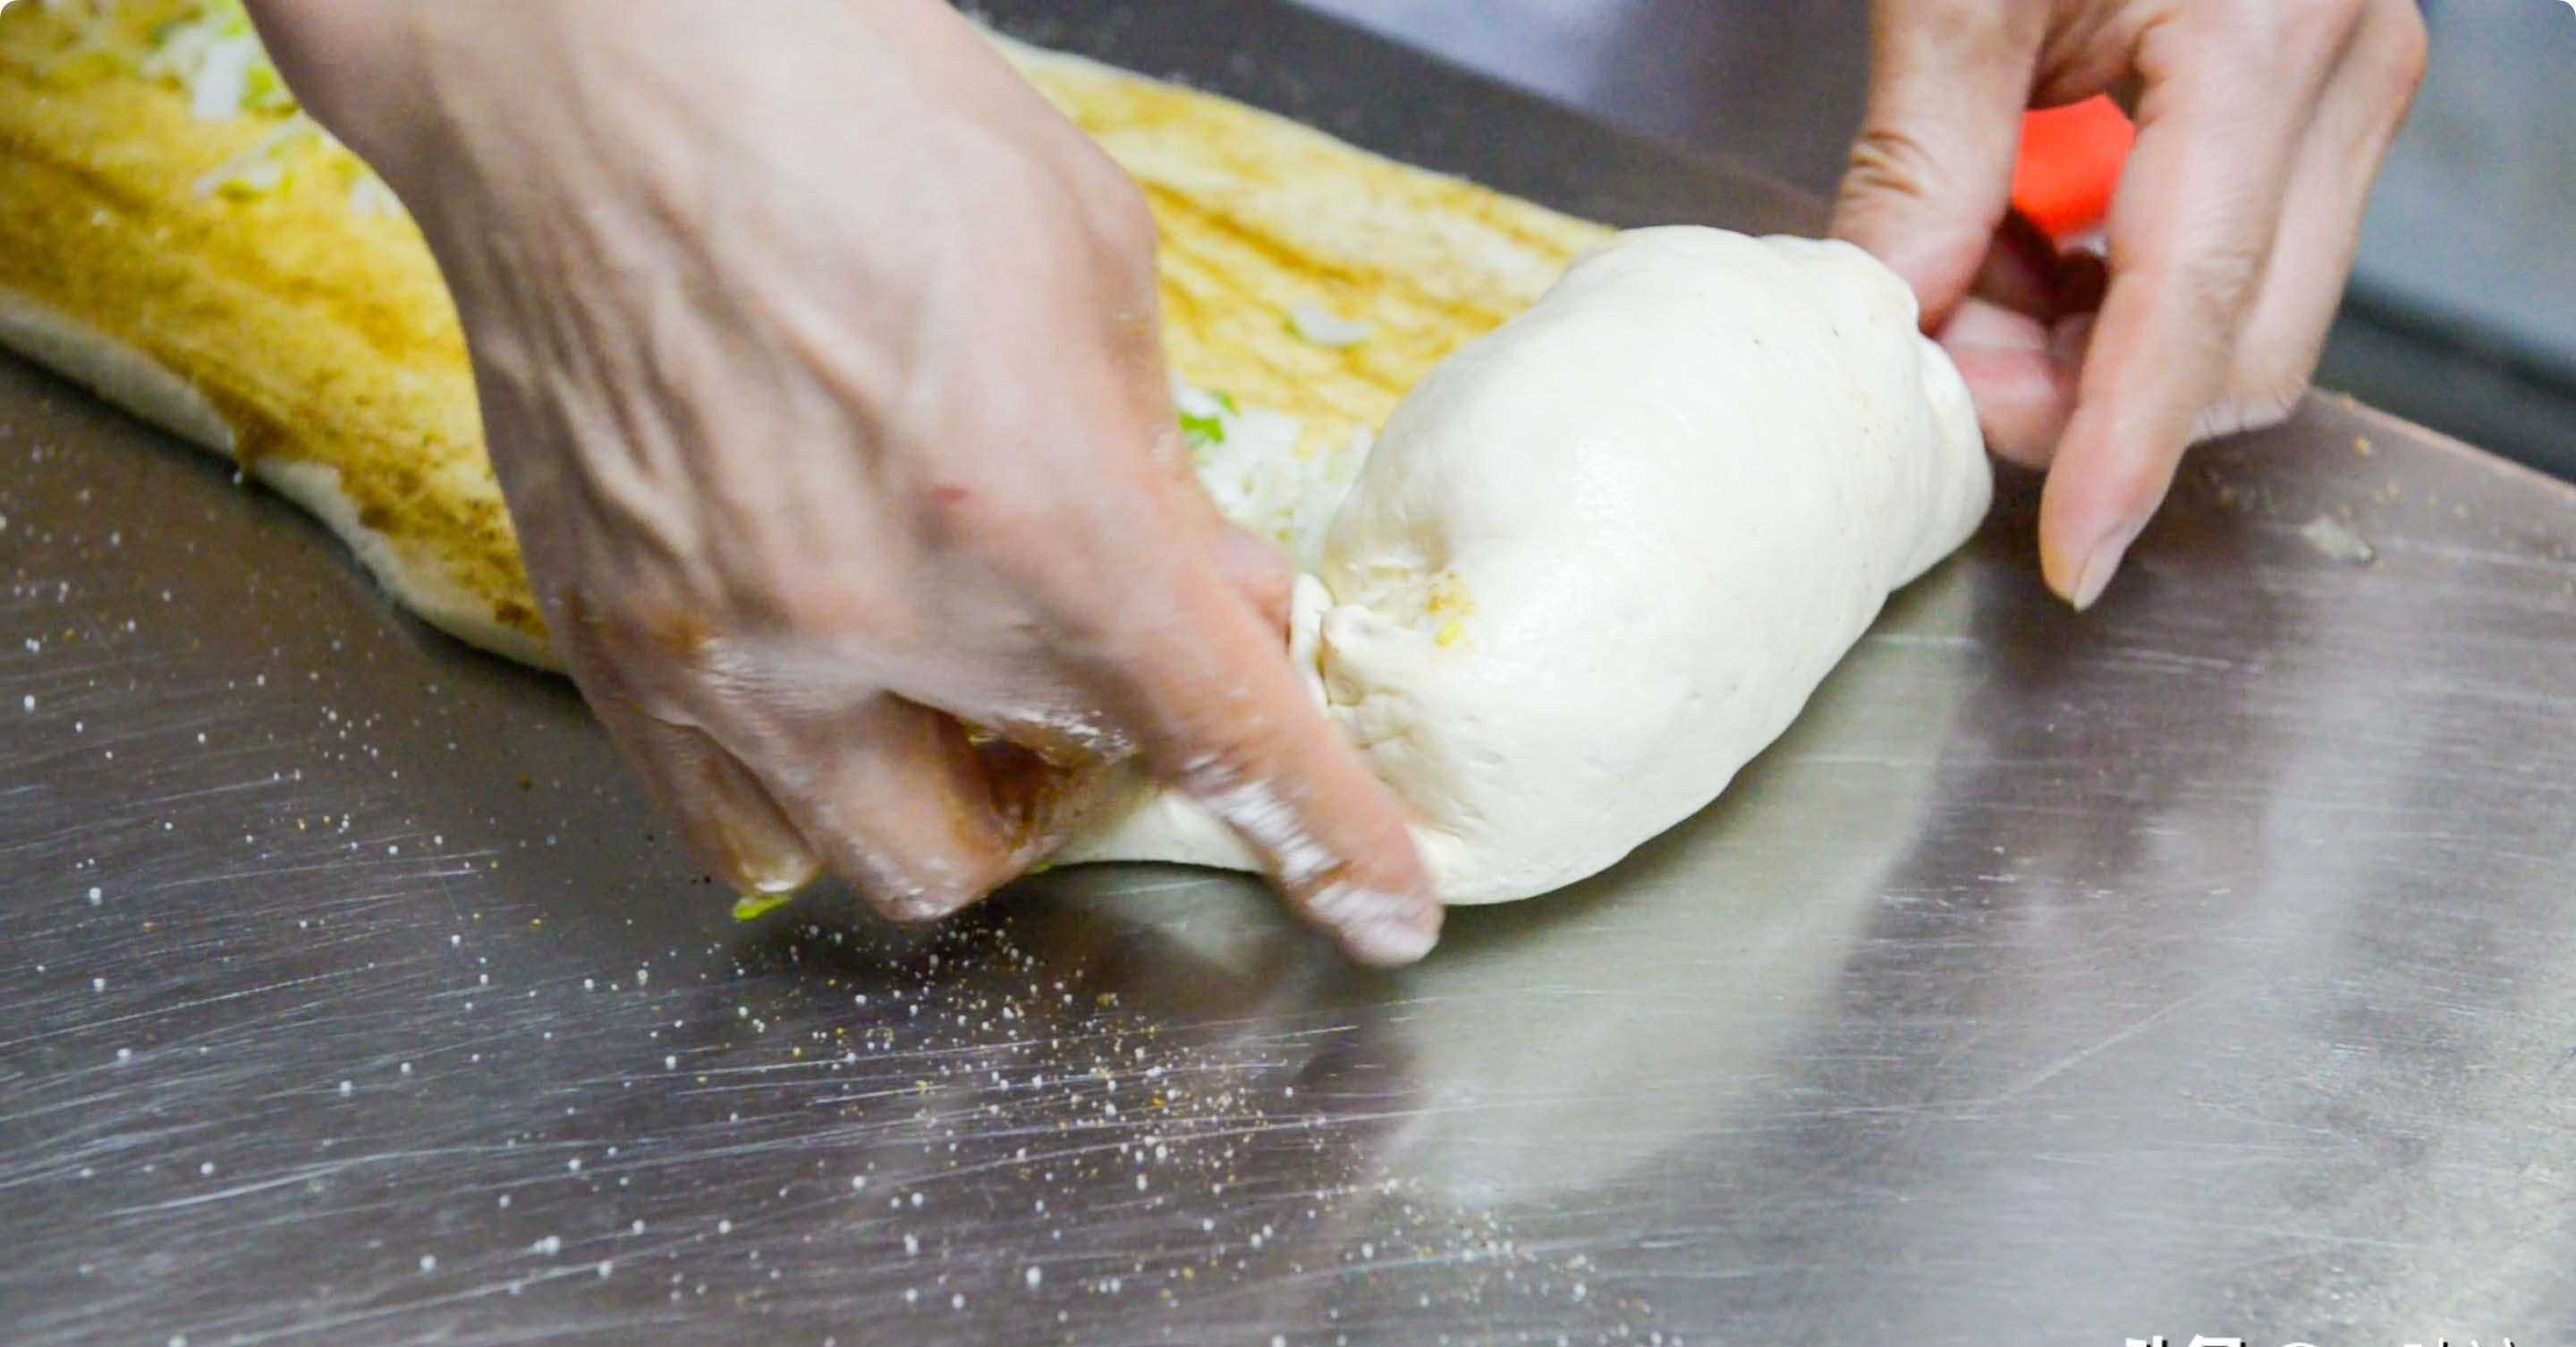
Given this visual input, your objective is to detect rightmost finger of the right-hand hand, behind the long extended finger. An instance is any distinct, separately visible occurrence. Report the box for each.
[2200,0,2424,433]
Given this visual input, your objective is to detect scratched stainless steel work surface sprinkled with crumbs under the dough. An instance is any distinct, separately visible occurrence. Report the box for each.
[0,5,2576,1347]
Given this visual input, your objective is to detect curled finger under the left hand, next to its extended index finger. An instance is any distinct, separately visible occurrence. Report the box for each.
[716,693,1051,922]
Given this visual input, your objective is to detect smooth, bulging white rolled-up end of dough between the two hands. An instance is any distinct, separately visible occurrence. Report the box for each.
[1062,226,1991,904]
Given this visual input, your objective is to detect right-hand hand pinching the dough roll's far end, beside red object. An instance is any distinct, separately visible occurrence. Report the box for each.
[1835,0,2424,608]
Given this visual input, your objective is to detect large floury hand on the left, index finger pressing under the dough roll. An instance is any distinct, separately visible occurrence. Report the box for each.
[258,0,1440,963]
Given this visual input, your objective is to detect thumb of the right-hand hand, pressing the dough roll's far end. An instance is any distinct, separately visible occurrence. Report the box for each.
[1835,3,2046,332]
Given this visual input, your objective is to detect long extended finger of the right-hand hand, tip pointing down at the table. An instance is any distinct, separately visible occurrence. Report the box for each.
[2040,5,2342,608]
